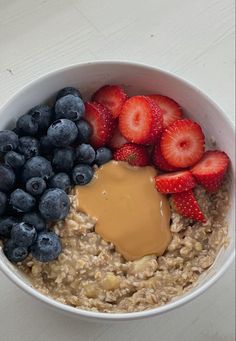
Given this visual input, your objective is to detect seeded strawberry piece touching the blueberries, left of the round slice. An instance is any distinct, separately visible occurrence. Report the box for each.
[84,102,115,148]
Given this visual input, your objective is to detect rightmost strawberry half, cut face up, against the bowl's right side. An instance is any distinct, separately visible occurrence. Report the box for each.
[191,150,229,192]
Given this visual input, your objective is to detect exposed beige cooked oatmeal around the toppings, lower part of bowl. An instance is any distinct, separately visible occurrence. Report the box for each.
[17,181,229,313]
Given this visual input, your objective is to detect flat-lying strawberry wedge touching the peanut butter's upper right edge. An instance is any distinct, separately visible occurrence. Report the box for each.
[155,171,196,194]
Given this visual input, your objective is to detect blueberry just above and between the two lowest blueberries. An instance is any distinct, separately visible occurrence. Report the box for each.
[11,221,37,247]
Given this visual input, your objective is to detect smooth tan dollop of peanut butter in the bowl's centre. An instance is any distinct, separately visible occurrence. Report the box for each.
[76,161,171,260]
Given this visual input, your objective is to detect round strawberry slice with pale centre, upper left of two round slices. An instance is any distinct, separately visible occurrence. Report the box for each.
[119,96,163,144]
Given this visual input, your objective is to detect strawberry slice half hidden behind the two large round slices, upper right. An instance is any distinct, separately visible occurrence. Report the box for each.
[148,95,183,128]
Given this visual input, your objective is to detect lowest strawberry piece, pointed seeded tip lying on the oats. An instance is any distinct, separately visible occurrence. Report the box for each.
[172,189,206,223]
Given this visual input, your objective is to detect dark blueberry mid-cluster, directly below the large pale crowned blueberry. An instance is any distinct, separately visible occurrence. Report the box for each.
[52,147,75,172]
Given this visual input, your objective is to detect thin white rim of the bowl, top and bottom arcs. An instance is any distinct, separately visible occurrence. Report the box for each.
[0,59,235,321]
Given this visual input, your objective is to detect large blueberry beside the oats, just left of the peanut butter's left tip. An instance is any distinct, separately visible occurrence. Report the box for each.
[39,188,70,221]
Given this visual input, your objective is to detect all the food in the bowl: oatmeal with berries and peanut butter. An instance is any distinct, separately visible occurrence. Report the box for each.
[0,84,230,313]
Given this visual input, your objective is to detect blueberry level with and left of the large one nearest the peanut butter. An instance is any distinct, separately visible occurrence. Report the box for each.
[9,188,36,212]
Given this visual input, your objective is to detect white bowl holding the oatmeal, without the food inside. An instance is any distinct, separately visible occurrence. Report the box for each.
[0,61,235,321]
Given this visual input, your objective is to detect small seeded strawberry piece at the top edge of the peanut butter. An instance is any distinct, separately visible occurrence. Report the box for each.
[113,143,149,167]
